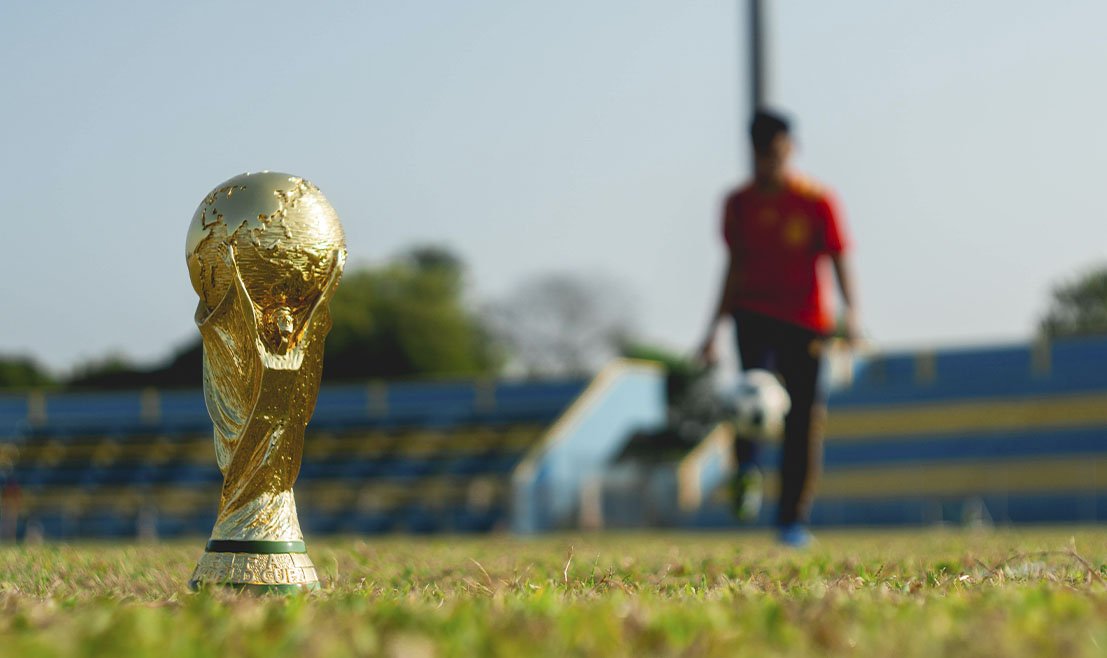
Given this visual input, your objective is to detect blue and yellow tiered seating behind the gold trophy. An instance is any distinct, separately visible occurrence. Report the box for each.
[0,379,587,538]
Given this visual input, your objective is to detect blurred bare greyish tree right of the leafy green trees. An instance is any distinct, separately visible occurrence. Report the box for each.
[488,274,633,374]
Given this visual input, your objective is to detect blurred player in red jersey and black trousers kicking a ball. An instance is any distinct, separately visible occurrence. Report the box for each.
[700,111,859,547]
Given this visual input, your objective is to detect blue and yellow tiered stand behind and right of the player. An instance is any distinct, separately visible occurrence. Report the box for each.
[683,338,1107,527]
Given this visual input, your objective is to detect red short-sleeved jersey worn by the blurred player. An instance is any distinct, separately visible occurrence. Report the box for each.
[723,172,847,332]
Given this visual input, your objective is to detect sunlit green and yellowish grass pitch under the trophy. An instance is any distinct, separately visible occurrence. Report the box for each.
[0,528,1107,658]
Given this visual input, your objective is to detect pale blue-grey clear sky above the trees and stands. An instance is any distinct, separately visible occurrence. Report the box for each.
[0,0,1107,371]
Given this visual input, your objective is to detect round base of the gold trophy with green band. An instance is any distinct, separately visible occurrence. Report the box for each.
[188,539,321,594]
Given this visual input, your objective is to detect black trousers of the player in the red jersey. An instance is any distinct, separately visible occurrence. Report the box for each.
[734,310,826,525]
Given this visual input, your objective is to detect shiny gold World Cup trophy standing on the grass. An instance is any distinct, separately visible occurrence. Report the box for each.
[186,172,346,592]
